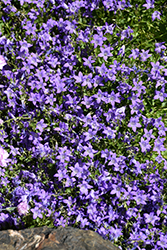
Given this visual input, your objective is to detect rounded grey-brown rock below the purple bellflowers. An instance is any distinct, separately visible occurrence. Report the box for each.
[0,226,120,250]
